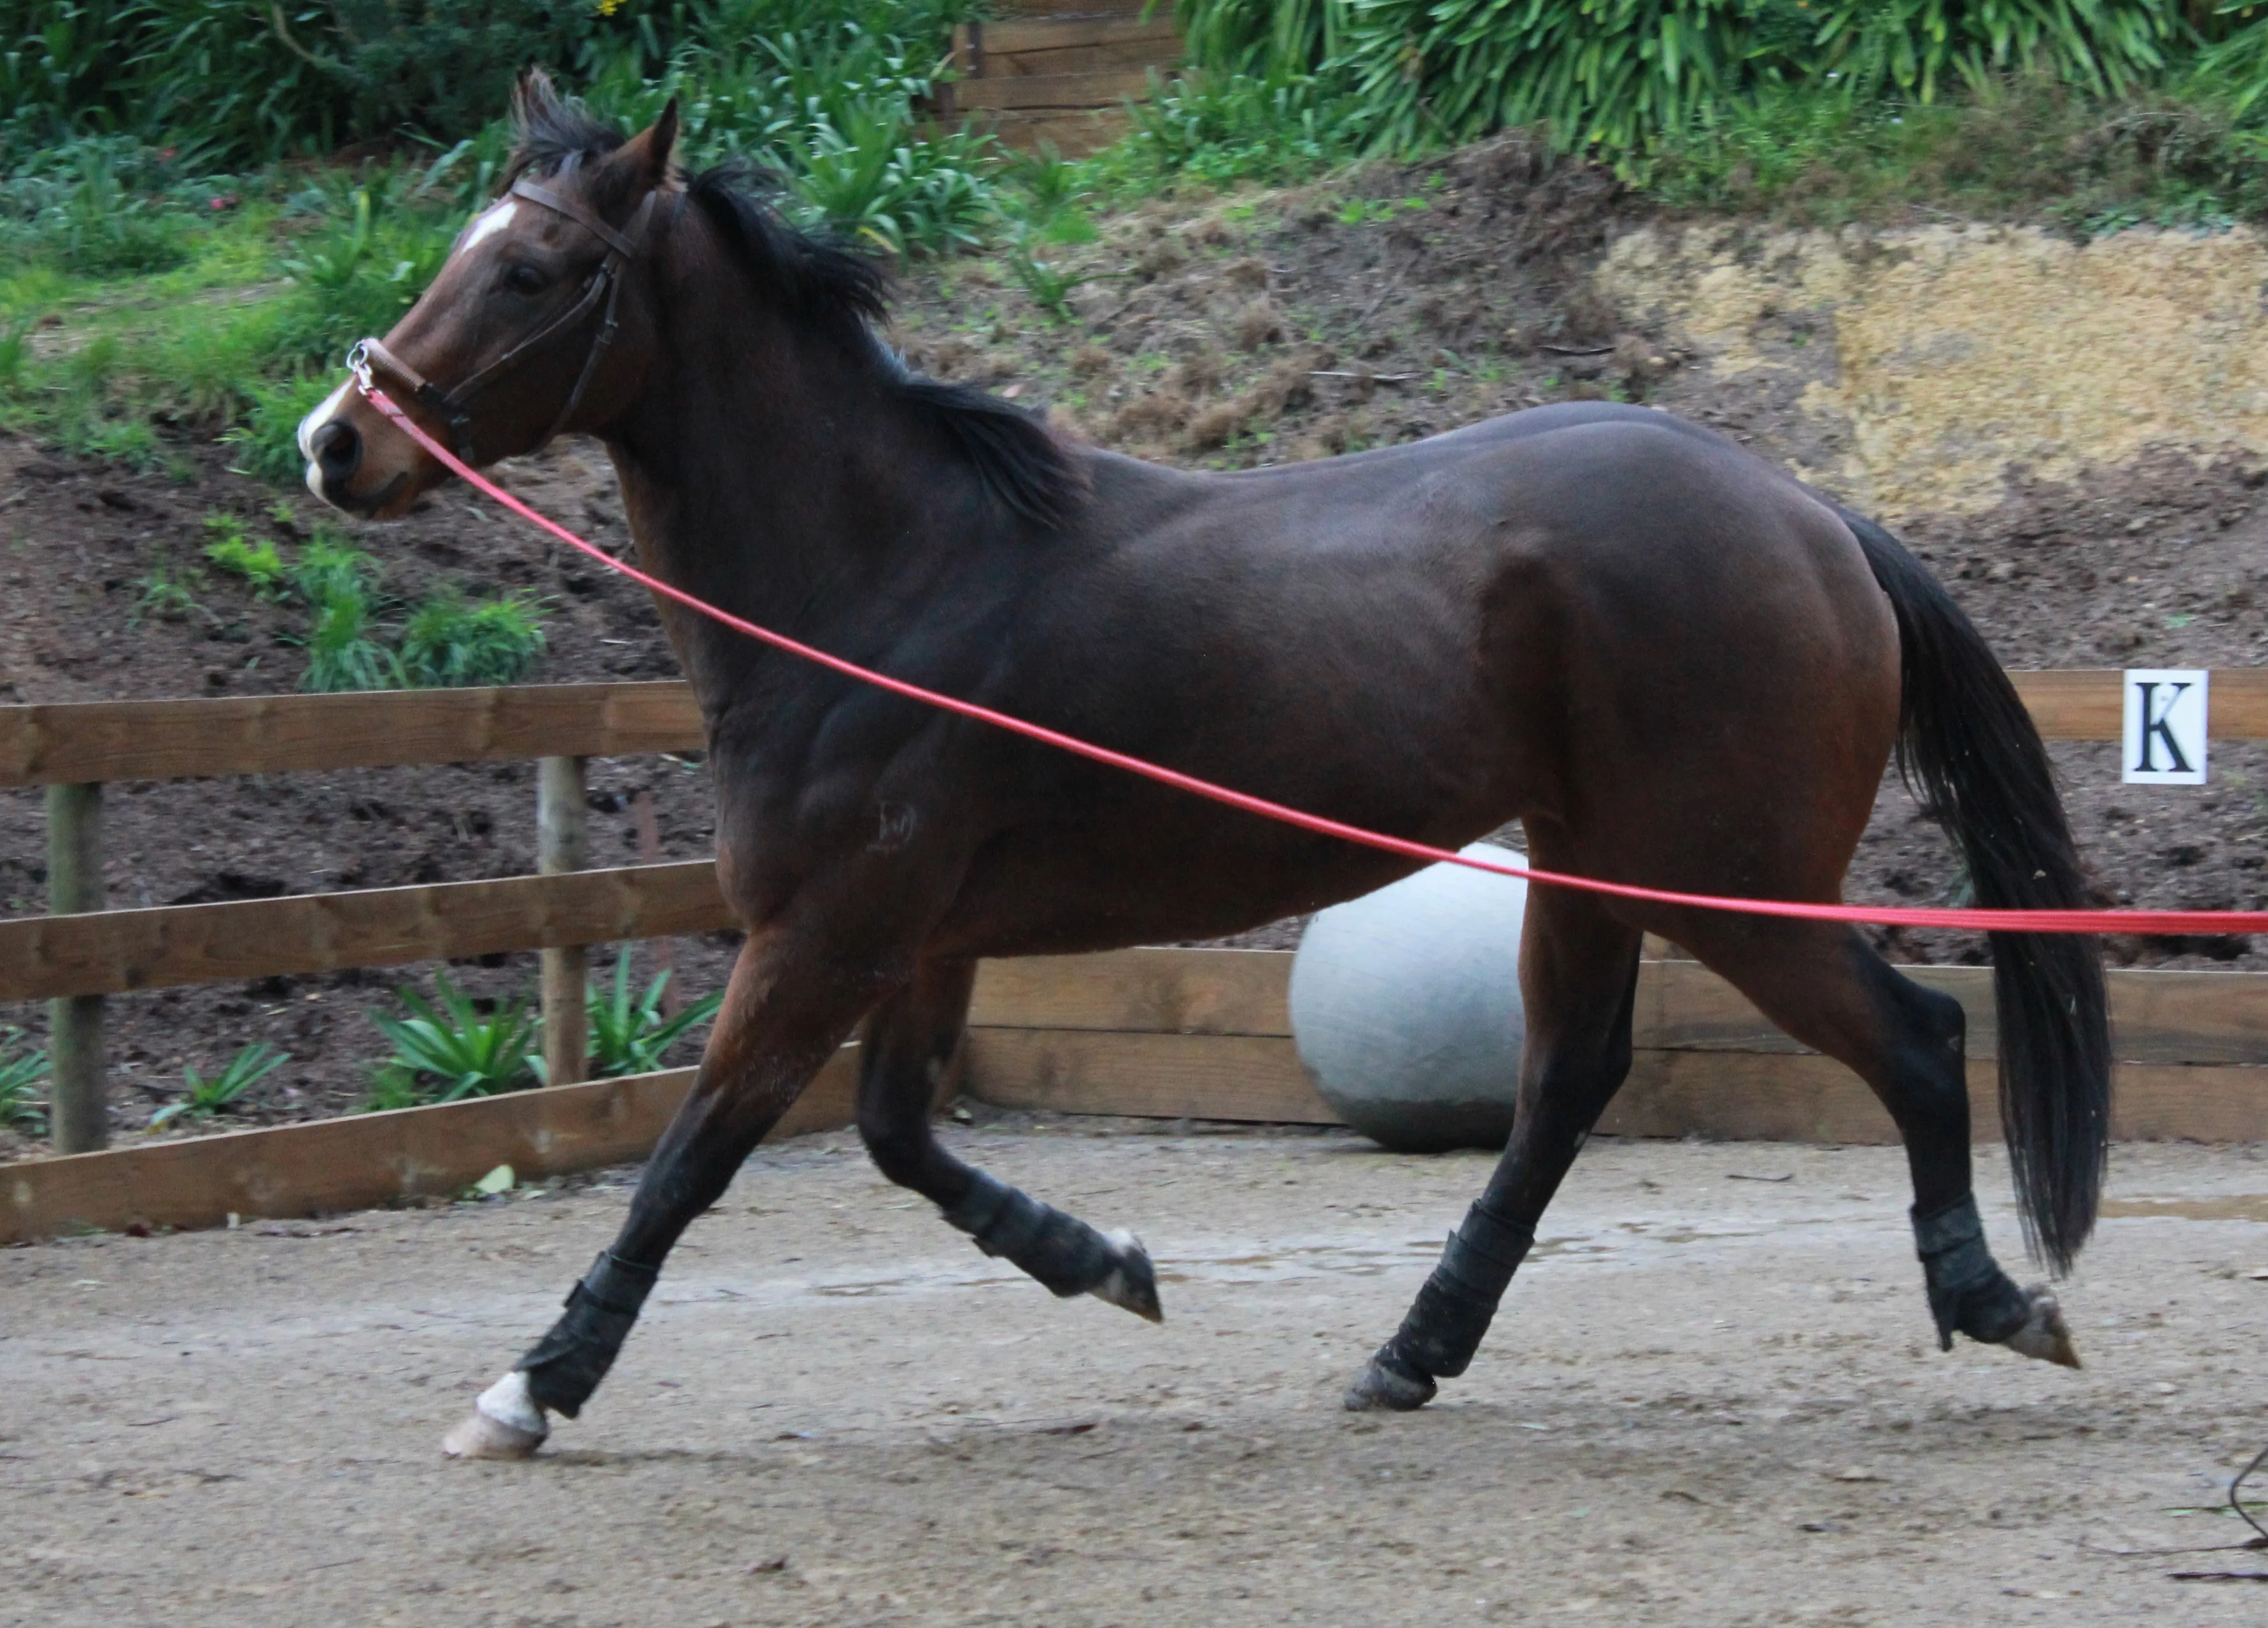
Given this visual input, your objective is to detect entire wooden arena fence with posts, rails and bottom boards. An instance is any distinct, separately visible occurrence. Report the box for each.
[0,669,2268,1241]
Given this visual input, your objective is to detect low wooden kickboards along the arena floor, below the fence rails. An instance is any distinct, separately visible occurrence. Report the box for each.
[13,950,2268,1242]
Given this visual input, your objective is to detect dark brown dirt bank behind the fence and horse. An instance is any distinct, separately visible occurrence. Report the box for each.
[0,138,2268,1157]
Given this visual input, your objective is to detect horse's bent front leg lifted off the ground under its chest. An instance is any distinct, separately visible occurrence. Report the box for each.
[858,961,1161,1322]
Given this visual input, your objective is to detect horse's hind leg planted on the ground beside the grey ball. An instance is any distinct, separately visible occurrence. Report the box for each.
[1347,889,1640,1410]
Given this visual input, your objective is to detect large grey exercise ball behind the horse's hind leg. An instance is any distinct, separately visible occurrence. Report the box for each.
[1290,844,1529,1152]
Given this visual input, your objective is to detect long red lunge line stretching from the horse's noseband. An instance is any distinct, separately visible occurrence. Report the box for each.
[358,376,2268,934]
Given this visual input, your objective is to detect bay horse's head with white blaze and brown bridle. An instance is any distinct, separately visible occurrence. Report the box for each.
[299,73,678,519]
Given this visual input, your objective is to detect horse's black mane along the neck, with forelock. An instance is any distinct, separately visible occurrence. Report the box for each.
[506,82,1087,531]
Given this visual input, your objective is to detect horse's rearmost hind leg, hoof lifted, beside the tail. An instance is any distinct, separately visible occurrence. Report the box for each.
[1678,918,2080,1367]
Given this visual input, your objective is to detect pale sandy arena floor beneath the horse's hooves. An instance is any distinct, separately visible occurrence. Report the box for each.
[0,1118,2268,1628]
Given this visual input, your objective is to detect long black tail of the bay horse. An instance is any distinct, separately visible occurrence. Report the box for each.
[1844,512,2111,1272]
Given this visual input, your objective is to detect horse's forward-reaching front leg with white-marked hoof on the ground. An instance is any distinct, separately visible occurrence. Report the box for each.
[442,925,902,1458]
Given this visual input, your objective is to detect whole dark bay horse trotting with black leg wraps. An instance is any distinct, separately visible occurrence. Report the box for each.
[299,75,2109,1456]
